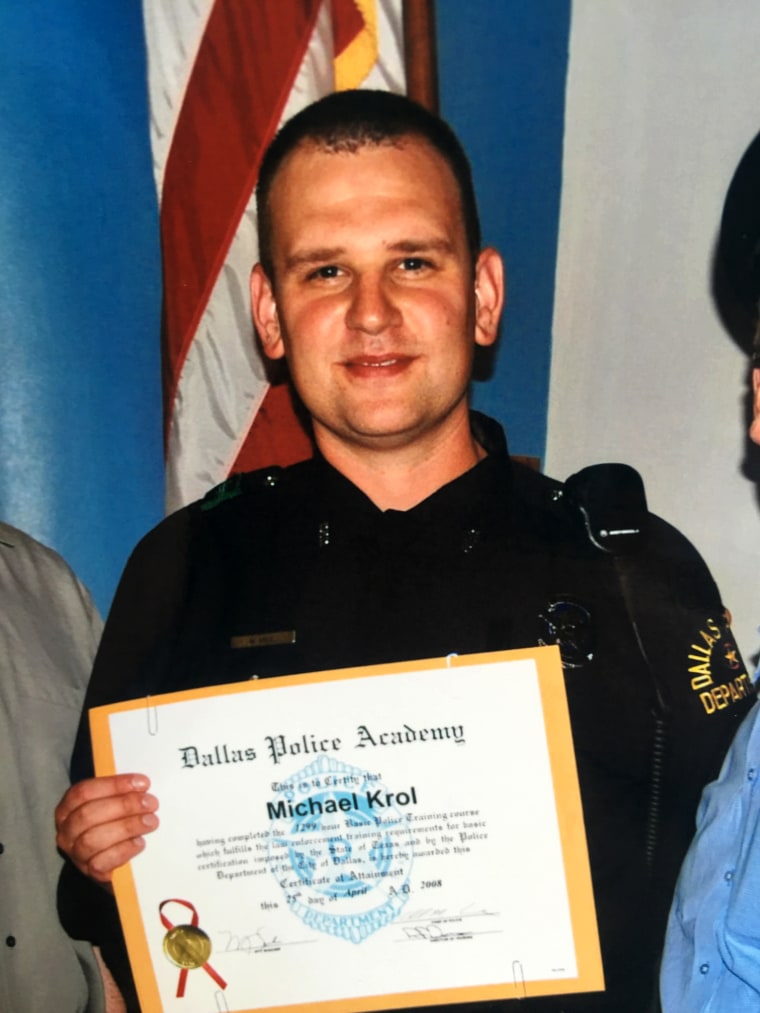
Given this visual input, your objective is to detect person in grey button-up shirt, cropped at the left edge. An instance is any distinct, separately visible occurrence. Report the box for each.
[0,524,122,1013]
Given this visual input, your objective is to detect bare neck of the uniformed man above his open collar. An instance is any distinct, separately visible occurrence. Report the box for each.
[315,411,486,511]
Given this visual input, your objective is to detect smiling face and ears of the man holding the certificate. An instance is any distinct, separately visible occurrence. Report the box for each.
[251,137,503,450]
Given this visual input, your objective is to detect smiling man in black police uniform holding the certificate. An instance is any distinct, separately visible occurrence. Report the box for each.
[58,92,750,1013]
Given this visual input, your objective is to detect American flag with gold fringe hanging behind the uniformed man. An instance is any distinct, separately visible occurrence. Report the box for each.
[144,0,405,512]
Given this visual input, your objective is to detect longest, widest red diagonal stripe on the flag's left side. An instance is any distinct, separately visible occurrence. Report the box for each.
[161,0,321,441]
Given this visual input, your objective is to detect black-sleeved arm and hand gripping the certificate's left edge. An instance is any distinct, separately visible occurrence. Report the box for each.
[57,511,192,1010]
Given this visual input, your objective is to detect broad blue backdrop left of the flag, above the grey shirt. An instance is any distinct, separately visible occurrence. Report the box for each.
[0,0,163,610]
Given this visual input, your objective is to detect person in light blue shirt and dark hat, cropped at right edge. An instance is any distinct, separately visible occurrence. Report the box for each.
[661,130,760,1013]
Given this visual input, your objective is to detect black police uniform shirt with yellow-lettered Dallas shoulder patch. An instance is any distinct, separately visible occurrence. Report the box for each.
[61,413,754,1013]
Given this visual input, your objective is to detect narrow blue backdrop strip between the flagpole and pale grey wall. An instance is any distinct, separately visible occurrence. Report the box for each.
[436,0,569,458]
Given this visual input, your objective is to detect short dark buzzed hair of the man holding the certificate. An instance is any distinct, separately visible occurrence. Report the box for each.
[256,89,480,278]
